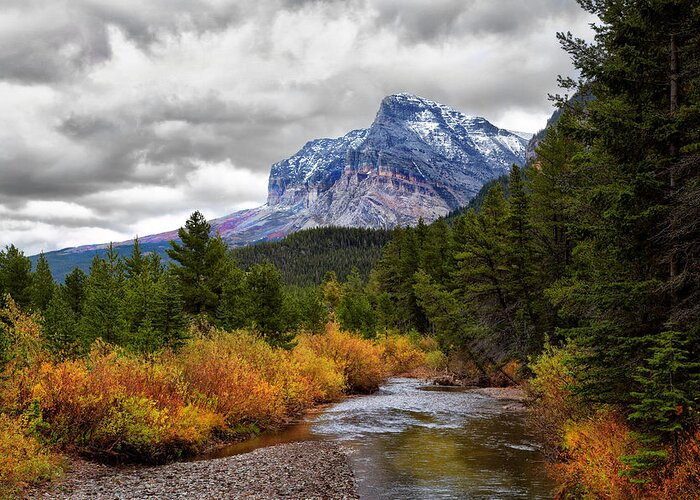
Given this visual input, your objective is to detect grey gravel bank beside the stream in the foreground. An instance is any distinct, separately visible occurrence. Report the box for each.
[27,441,359,499]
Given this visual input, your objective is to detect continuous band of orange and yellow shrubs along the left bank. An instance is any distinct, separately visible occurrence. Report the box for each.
[0,300,425,496]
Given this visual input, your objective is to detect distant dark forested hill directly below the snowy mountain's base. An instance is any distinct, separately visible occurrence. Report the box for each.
[233,227,392,286]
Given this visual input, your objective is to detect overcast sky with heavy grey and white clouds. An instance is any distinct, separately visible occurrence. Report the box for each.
[0,0,591,254]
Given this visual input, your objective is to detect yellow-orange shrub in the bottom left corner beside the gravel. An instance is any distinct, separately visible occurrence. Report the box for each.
[0,413,63,498]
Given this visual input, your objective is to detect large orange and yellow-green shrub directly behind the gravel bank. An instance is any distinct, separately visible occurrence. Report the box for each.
[25,343,224,461]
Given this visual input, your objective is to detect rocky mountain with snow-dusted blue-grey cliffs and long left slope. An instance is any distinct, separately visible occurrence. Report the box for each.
[35,94,528,280]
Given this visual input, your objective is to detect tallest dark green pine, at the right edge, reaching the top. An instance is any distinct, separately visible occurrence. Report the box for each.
[548,0,700,467]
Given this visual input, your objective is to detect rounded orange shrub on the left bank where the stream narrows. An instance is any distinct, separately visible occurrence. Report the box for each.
[297,328,385,393]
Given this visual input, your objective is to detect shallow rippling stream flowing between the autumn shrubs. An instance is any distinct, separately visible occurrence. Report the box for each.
[201,378,553,499]
